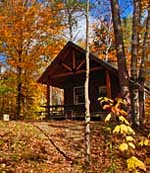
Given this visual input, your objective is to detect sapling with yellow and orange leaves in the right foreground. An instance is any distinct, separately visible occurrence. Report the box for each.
[98,97,150,173]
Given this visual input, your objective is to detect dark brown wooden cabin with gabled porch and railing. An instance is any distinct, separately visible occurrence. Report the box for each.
[38,41,120,117]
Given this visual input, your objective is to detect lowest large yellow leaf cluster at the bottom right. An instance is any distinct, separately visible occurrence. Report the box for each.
[127,156,146,171]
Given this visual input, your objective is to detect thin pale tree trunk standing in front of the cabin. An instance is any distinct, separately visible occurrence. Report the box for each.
[85,0,91,172]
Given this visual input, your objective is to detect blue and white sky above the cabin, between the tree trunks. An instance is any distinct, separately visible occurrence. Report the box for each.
[73,0,133,39]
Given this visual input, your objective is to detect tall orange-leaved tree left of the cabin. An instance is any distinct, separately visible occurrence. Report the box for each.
[0,0,61,119]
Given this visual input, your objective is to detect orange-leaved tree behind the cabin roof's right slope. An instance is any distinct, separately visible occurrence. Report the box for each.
[91,19,116,62]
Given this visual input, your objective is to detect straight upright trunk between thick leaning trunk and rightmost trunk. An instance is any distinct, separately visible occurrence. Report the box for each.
[131,0,140,126]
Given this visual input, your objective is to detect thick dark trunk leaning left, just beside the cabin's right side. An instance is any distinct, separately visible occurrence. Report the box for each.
[110,0,130,105]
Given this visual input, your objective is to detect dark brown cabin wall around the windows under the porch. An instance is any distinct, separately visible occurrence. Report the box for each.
[64,69,117,115]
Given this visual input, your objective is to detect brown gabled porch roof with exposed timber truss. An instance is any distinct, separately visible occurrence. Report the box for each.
[38,41,118,88]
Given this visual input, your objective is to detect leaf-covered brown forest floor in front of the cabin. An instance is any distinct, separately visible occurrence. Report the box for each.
[0,120,150,173]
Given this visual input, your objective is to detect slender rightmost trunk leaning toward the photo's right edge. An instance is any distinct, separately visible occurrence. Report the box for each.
[139,8,150,127]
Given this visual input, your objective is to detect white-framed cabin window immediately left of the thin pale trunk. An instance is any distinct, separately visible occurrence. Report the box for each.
[73,86,85,105]
